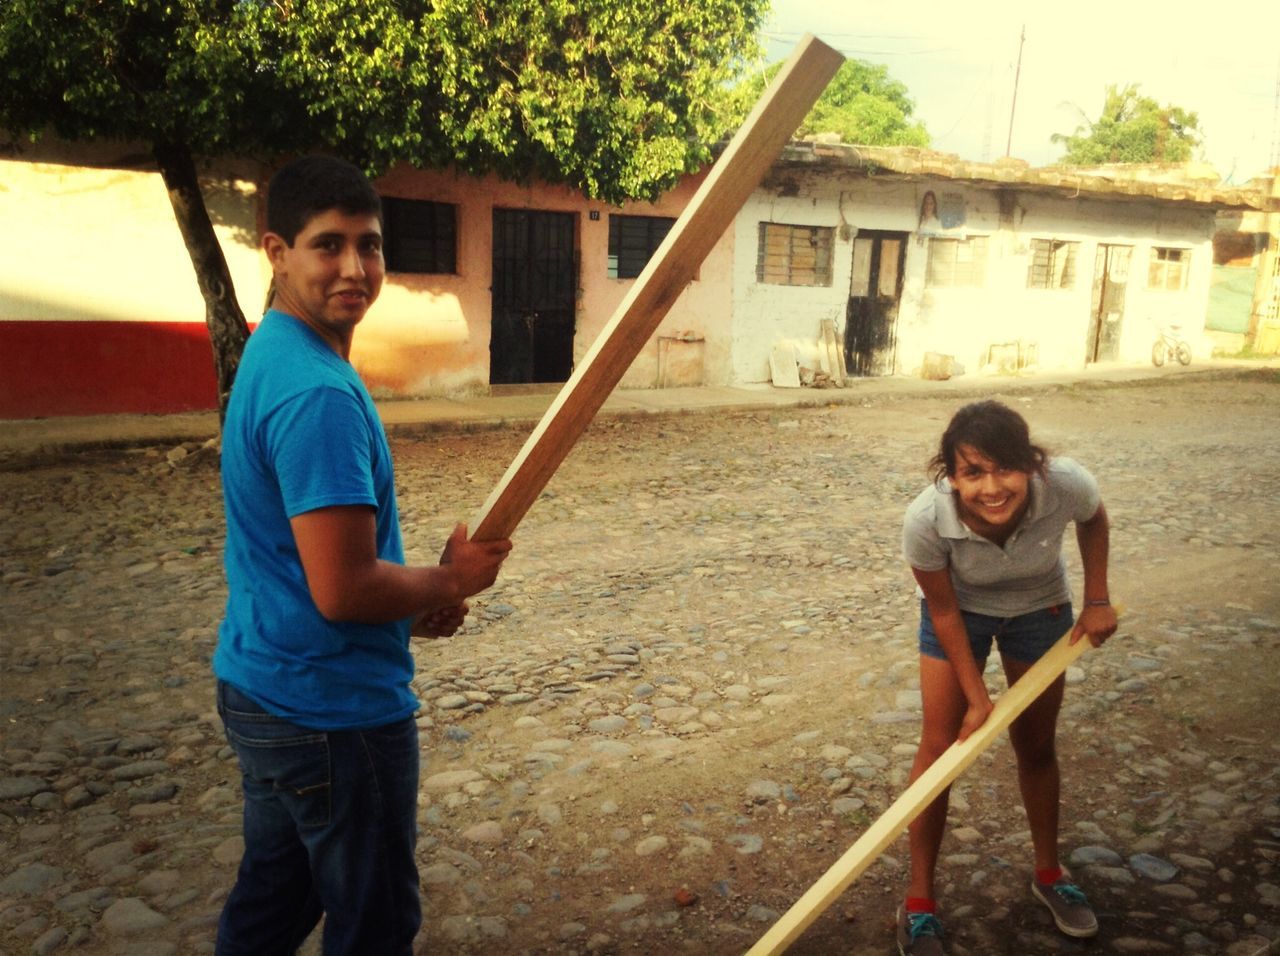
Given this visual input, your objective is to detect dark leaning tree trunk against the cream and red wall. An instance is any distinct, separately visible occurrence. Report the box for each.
[154,143,248,422]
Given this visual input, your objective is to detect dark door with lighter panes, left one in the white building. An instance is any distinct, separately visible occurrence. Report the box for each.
[845,229,906,375]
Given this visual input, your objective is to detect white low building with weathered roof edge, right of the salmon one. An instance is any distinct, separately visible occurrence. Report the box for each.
[730,145,1265,383]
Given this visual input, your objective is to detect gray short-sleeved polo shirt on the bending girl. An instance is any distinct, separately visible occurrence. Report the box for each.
[902,458,1102,617]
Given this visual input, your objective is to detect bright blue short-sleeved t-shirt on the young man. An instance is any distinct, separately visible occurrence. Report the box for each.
[214,310,419,731]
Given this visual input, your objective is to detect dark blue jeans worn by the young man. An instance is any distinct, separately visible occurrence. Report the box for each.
[215,681,422,956]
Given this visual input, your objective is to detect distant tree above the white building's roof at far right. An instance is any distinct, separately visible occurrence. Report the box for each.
[1051,83,1201,166]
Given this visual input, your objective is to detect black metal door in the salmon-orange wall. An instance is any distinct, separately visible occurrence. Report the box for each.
[489,209,577,385]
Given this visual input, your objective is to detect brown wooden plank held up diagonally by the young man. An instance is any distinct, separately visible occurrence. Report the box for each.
[471,35,845,541]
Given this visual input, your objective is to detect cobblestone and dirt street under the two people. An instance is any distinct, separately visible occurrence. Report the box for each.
[0,371,1280,956]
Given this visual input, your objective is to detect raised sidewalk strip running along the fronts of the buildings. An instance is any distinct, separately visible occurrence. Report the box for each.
[0,356,1280,457]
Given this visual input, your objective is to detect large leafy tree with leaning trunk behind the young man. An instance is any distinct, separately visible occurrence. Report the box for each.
[0,0,768,408]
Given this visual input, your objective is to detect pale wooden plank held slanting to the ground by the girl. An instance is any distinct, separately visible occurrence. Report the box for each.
[748,631,1091,956]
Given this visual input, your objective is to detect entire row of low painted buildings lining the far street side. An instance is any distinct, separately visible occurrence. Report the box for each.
[0,142,1280,418]
